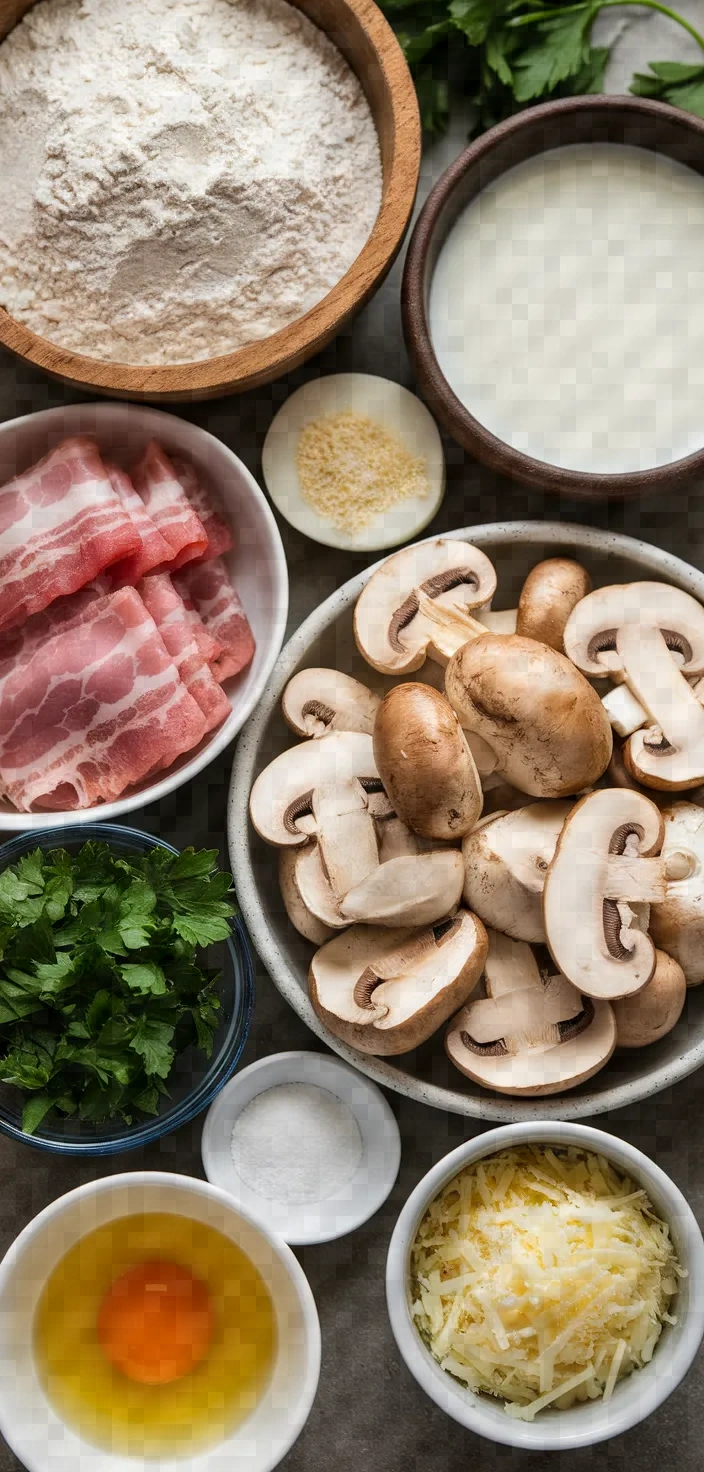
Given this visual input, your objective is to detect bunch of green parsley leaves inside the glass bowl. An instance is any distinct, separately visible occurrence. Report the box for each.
[0,842,236,1133]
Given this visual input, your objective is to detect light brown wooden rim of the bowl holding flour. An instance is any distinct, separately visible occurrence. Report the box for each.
[0,0,421,396]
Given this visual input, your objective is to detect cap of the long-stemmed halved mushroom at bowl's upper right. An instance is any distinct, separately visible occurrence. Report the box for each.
[564,583,704,679]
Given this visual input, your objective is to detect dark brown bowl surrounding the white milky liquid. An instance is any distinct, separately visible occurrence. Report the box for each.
[402,97,704,500]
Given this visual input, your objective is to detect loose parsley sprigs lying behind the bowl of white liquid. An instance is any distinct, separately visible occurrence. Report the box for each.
[380,0,704,134]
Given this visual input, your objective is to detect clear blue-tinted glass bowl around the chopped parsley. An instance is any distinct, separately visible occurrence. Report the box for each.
[0,823,255,1156]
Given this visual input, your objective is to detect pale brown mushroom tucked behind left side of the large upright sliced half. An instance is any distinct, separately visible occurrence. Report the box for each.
[462,802,571,944]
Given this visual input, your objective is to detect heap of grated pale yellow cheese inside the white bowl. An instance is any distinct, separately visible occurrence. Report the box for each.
[411,1145,686,1420]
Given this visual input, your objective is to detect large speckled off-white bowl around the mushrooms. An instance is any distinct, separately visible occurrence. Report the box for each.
[228,521,704,1122]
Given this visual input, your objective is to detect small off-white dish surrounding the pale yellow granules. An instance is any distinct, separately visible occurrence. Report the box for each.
[262,372,445,552]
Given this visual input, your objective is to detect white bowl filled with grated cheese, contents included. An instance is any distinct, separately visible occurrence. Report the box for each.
[386,1123,704,1451]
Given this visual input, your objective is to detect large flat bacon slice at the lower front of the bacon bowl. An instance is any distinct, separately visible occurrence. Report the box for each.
[0,587,206,813]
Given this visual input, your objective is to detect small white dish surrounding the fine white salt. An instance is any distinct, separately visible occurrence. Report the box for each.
[200,1052,401,1247]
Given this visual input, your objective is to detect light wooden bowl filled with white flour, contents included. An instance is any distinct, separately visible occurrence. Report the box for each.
[0,0,420,402]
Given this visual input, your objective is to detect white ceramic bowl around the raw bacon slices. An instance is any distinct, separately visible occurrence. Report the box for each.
[0,403,289,832]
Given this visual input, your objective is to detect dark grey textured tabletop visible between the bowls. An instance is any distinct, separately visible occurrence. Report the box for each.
[0,0,704,1472]
